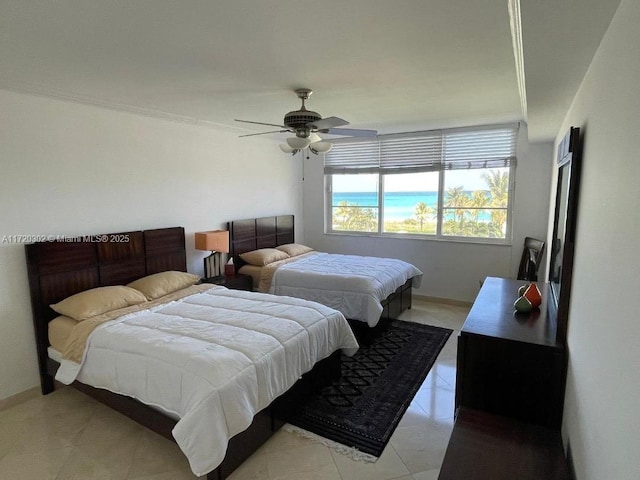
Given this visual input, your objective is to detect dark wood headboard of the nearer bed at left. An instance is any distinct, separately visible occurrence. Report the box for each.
[25,227,187,393]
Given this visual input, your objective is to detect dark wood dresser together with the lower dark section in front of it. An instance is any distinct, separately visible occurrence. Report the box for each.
[438,277,573,480]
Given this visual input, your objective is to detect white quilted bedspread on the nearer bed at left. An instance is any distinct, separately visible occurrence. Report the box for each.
[56,287,358,475]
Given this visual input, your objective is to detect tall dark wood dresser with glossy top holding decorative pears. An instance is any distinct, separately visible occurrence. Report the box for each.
[455,277,566,429]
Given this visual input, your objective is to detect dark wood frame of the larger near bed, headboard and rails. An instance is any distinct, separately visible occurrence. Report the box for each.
[25,227,340,480]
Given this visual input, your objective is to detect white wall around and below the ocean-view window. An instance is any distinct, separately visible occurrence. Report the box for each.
[304,124,553,302]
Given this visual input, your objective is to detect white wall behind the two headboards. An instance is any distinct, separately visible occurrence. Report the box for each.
[0,90,303,399]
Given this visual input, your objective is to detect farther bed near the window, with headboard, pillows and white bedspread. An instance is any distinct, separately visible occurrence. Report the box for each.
[228,215,422,327]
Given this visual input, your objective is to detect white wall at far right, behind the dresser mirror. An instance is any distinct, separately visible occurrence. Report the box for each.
[557,0,640,480]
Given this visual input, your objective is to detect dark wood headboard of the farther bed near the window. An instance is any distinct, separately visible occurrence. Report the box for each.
[227,215,295,269]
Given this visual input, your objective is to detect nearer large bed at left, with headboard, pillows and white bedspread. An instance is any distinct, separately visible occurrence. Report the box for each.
[26,227,357,480]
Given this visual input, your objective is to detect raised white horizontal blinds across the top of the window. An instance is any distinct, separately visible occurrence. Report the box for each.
[324,124,518,174]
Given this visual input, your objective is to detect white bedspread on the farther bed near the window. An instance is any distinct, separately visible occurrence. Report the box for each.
[270,253,422,327]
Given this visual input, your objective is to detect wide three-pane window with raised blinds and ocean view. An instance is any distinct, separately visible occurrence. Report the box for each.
[325,125,518,242]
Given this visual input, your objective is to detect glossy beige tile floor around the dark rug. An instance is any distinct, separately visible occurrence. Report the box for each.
[0,300,469,480]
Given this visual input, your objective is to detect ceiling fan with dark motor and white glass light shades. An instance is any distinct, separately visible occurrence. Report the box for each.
[236,88,378,155]
